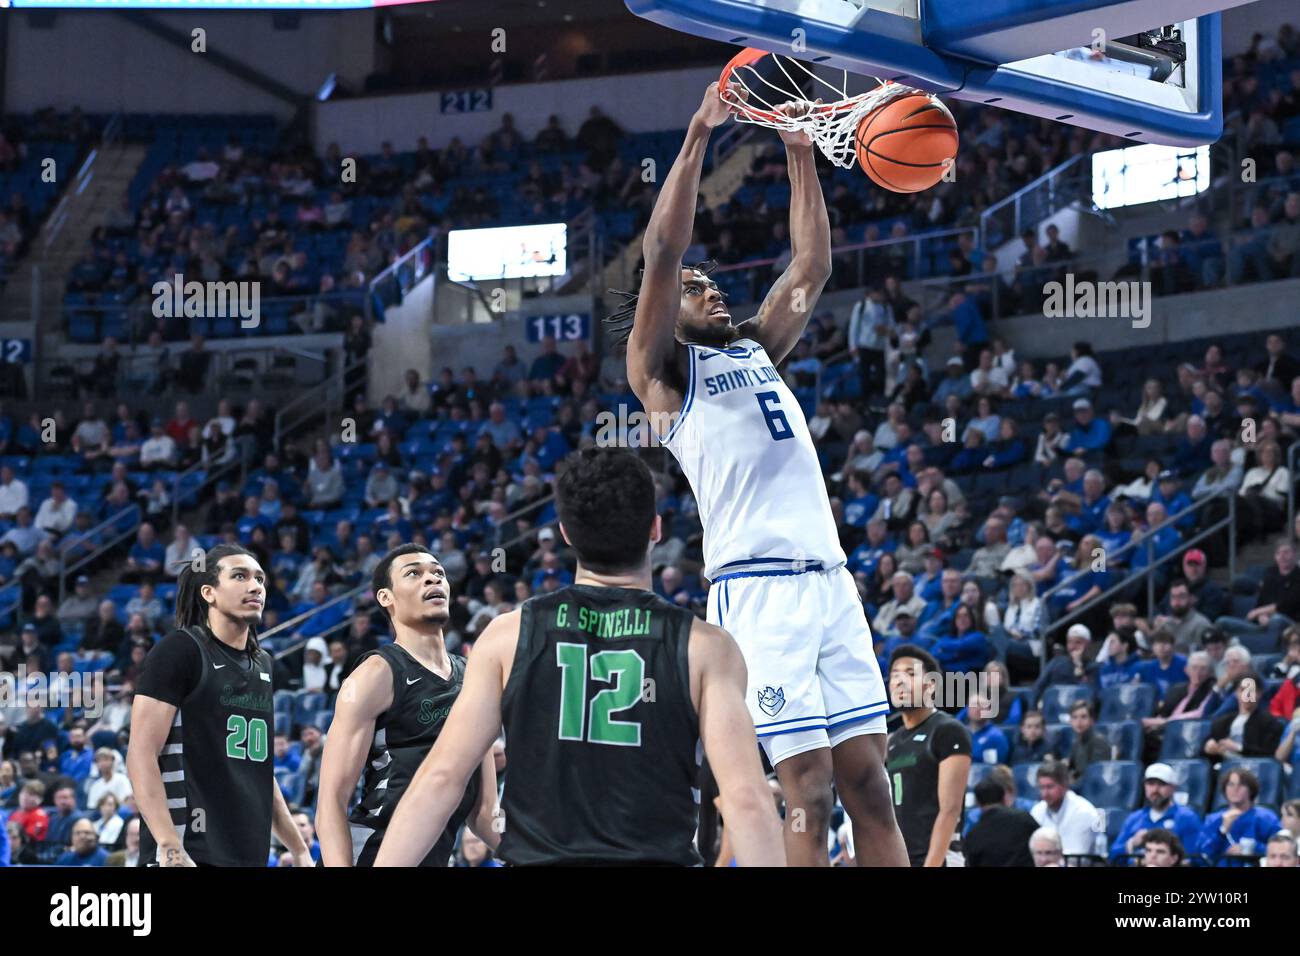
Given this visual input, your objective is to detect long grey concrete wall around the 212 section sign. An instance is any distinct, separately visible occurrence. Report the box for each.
[316,68,718,153]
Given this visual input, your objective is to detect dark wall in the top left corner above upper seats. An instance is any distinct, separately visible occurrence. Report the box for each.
[3,10,376,118]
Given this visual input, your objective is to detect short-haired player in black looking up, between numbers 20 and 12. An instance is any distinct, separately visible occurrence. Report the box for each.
[316,544,501,866]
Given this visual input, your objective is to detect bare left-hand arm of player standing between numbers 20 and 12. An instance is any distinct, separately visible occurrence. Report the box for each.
[316,656,393,866]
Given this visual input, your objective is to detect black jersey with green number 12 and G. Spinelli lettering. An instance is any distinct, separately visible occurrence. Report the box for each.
[501,585,699,866]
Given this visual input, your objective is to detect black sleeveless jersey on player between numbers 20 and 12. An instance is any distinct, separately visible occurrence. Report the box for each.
[348,644,481,866]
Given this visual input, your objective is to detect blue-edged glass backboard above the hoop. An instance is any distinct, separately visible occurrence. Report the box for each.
[625,0,1248,146]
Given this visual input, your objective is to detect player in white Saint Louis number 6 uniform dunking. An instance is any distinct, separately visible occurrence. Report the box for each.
[611,83,907,866]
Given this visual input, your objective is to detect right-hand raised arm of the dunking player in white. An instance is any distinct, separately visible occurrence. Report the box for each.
[741,103,831,364]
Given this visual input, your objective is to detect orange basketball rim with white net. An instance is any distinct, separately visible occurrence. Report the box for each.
[718,47,928,169]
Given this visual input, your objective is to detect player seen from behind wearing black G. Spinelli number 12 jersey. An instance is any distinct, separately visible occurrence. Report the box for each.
[376,449,785,866]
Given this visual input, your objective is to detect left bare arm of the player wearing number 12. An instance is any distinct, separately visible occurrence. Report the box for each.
[374,611,519,866]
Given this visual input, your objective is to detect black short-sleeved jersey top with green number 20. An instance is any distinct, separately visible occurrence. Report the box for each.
[135,626,276,866]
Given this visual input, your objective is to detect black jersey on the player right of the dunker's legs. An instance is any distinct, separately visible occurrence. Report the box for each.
[885,710,971,866]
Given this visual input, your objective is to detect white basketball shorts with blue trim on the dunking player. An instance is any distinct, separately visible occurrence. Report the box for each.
[709,559,889,767]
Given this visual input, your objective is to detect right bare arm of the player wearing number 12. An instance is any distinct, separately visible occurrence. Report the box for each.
[689,620,785,866]
